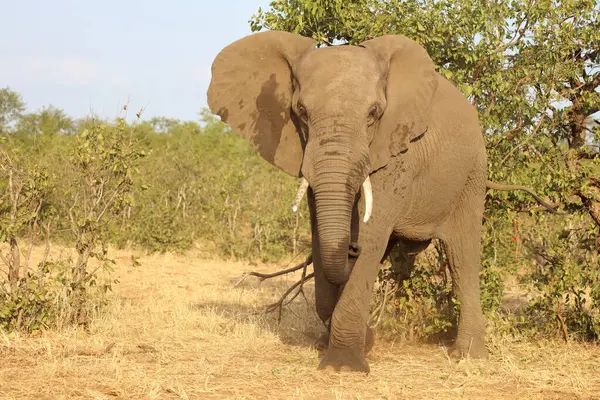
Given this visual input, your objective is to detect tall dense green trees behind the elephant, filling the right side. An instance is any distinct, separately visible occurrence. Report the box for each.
[250,0,600,339]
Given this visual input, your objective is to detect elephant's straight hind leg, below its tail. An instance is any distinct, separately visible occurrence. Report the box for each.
[440,188,488,358]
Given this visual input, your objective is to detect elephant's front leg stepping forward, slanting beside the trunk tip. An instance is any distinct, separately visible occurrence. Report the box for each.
[319,225,391,372]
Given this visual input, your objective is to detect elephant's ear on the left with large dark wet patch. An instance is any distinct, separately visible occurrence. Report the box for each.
[207,31,316,176]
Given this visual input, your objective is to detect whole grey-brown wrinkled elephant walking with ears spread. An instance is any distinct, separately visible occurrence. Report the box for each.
[208,32,487,371]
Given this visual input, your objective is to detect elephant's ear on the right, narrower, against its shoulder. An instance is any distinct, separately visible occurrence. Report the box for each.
[361,35,438,170]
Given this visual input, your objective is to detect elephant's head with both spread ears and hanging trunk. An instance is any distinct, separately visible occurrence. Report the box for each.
[208,31,437,284]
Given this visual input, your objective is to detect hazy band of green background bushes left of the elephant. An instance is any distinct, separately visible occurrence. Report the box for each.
[5,87,309,261]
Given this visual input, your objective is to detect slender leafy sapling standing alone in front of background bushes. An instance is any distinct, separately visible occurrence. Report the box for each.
[66,119,145,326]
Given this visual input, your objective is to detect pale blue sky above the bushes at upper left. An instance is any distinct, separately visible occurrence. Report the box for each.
[0,0,269,120]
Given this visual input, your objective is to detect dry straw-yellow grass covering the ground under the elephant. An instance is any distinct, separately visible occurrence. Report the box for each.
[0,245,600,399]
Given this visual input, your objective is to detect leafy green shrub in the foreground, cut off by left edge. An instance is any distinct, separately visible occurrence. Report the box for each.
[0,150,57,331]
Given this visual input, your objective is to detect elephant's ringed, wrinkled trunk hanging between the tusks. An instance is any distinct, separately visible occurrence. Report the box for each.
[303,120,372,285]
